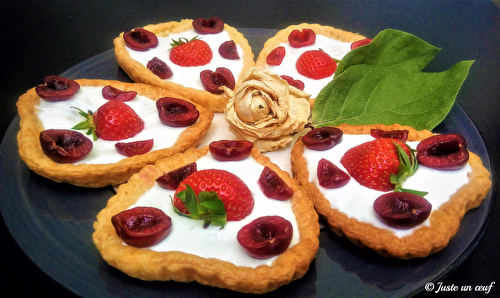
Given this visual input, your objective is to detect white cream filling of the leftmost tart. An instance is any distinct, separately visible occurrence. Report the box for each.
[38,86,185,164]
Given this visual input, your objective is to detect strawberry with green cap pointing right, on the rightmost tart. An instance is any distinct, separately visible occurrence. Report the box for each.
[340,138,418,193]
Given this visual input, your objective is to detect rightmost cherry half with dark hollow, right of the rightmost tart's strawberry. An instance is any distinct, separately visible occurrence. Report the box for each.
[417,134,469,171]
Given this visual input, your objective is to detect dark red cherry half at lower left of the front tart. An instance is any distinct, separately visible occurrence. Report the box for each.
[111,207,172,248]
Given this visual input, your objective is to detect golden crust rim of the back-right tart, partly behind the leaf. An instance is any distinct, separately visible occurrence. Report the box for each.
[255,23,365,108]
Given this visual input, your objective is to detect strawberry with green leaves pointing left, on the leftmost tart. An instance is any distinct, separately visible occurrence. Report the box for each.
[73,100,144,141]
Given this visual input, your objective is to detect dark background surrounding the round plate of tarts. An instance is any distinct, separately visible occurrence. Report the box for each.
[0,0,500,297]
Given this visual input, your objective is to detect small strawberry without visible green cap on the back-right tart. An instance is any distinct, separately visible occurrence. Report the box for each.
[295,50,337,80]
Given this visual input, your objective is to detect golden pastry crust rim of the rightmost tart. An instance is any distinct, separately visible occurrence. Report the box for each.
[291,125,491,259]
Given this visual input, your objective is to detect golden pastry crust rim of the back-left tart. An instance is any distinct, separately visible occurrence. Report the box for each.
[114,19,255,113]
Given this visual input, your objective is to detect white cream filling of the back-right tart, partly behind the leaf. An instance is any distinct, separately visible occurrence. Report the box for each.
[266,34,351,98]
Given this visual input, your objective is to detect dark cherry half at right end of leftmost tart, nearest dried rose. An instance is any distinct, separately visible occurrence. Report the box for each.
[156,97,200,127]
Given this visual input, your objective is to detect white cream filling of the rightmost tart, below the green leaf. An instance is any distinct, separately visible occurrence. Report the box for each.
[304,134,471,237]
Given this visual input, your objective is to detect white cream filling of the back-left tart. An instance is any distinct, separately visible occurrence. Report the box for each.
[126,29,244,90]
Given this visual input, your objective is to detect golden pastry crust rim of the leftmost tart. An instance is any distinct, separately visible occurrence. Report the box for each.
[17,79,214,188]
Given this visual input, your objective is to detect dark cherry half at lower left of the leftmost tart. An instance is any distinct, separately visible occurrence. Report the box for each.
[39,129,93,163]
